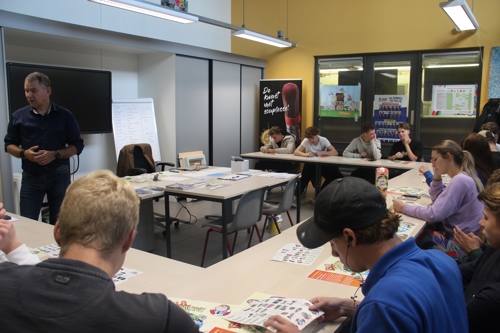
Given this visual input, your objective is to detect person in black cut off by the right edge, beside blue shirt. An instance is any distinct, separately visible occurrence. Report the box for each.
[460,183,500,333]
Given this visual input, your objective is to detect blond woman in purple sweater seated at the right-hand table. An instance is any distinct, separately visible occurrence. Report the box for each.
[393,140,483,258]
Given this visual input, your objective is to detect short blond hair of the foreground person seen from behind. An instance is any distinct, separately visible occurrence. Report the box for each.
[58,170,139,257]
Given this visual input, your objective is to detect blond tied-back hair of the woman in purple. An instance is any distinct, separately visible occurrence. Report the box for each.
[432,140,484,192]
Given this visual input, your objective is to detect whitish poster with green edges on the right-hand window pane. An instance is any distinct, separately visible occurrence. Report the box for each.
[431,84,478,116]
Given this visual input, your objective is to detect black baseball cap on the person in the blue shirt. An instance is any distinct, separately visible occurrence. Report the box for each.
[297,177,387,249]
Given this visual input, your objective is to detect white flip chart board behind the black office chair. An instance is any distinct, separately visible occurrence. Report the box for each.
[112,98,161,161]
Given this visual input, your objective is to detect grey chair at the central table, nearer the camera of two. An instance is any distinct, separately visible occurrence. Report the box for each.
[201,188,266,267]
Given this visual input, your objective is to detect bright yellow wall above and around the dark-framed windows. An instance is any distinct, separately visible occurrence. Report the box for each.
[231,0,500,128]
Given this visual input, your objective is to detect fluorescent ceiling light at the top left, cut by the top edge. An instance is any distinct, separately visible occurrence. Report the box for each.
[88,0,198,23]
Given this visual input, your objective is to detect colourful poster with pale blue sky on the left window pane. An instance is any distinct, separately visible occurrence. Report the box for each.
[319,85,361,119]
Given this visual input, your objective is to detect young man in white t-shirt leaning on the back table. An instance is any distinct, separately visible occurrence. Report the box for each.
[293,126,343,194]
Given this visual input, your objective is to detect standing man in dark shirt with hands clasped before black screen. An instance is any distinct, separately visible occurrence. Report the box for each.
[4,72,84,224]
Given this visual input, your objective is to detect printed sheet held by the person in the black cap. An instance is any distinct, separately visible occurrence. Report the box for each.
[224,297,323,330]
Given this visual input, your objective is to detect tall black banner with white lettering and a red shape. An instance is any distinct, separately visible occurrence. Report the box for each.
[259,79,302,146]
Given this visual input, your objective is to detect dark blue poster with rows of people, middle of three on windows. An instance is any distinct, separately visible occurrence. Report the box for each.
[373,95,408,142]
